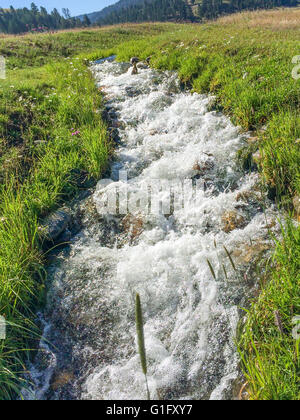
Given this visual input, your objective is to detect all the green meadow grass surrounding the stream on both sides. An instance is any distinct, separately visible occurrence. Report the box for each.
[0,9,300,400]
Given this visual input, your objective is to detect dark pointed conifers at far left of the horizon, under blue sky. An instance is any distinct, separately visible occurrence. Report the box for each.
[0,3,90,34]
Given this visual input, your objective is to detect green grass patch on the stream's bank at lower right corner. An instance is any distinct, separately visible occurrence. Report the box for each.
[239,220,300,400]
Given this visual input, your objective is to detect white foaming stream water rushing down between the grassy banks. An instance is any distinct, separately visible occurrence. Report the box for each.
[24,62,277,399]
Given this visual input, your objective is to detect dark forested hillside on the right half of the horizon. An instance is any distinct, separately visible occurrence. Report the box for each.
[97,0,298,25]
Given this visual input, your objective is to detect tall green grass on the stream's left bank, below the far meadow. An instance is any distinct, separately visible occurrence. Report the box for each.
[0,60,110,399]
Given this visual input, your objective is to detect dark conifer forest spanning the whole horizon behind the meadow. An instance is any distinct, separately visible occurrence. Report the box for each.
[0,0,298,34]
